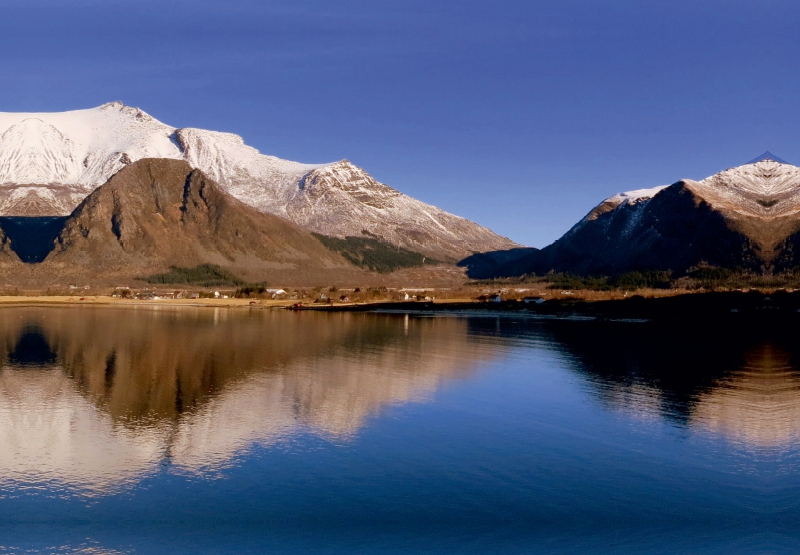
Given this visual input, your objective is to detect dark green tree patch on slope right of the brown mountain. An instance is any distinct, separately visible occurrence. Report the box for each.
[313,233,438,274]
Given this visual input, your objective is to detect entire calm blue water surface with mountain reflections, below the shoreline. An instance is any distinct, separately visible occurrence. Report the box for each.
[0,307,800,554]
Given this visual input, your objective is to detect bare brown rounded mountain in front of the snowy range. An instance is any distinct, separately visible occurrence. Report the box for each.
[37,159,359,284]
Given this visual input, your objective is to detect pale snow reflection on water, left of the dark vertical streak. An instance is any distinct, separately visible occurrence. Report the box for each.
[0,367,169,493]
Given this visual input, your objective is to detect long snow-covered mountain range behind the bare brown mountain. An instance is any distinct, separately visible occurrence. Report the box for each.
[0,102,519,259]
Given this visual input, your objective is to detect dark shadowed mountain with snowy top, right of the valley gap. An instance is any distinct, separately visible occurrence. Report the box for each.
[472,153,800,277]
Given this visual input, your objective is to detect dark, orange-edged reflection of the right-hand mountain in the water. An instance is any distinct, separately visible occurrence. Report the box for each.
[547,323,800,448]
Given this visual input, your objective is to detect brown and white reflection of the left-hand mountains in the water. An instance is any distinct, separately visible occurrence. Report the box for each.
[0,308,492,492]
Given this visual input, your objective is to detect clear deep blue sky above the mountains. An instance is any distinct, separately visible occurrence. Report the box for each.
[0,0,800,247]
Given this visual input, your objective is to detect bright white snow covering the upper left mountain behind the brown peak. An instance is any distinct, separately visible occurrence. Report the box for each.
[0,101,328,215]
